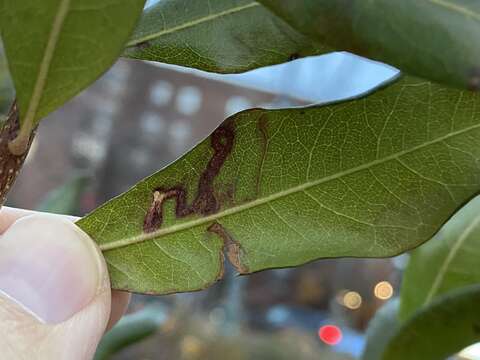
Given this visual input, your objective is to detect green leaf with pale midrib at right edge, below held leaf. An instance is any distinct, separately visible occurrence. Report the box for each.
[400,197,480,319]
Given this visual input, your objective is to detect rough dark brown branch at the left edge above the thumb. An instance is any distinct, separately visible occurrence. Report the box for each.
[0,101,36,206]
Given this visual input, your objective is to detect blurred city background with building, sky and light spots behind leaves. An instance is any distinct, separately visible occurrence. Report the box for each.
[0,33,420,360]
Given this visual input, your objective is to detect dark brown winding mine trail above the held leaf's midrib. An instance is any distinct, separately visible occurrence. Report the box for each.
[143,120,235,232]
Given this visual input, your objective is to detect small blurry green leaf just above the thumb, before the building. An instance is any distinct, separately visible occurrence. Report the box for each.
[37,174,90,215]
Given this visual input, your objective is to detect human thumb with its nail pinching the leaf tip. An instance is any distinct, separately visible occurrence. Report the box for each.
[0,214,111,360]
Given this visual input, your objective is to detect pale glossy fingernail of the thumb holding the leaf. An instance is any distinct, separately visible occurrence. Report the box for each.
[0,214,103,324]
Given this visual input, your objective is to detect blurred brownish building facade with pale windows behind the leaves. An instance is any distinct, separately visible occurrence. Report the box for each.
[9,60,300,211]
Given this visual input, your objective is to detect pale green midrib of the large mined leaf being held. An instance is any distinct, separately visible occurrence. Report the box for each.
[99,124,480,251]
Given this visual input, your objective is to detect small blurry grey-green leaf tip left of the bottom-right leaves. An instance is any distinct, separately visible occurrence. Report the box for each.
[362,298,400,360]
